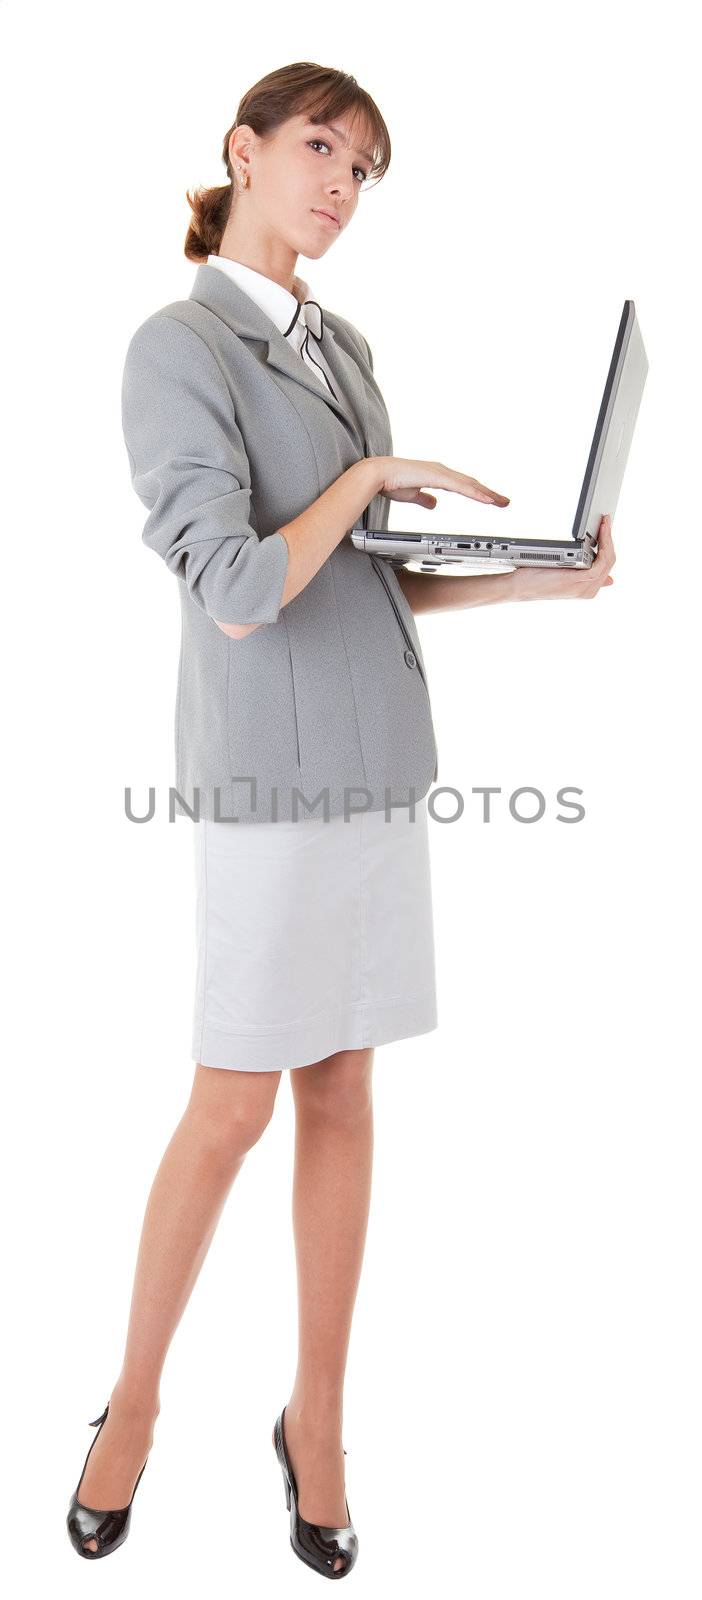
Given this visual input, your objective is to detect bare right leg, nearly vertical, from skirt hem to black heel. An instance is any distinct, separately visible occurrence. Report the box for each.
[283,1048,373,1570]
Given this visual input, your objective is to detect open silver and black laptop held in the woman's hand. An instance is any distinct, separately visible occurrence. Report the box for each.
[350,299,648,573]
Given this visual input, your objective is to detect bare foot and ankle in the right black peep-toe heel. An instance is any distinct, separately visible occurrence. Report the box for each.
[283,1406,349,1571]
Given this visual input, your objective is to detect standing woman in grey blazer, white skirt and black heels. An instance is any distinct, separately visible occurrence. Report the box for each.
[67,62,614,1578]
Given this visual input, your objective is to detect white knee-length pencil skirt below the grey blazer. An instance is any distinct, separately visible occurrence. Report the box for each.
[192,797,438,1072]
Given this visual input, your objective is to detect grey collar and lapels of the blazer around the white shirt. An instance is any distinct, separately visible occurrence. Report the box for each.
[189,261,368,448]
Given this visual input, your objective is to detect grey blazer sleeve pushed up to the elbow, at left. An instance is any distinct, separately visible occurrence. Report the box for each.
[122,312,289,624]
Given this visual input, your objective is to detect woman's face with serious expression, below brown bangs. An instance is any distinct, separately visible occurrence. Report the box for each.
[232,114,371,261]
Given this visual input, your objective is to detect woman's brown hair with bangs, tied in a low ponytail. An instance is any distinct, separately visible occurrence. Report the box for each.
[184,61,390,261]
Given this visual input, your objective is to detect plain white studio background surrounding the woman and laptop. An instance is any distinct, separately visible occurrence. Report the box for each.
[0,0,702,1600]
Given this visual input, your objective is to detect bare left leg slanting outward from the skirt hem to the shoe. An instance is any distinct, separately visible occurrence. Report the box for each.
[78,1062,280,1549]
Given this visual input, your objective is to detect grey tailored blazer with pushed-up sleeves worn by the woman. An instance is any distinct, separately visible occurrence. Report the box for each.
[122,264,438,822]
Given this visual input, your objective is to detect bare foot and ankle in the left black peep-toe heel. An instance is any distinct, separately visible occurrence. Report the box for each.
[78,1387,160,1550]
